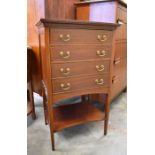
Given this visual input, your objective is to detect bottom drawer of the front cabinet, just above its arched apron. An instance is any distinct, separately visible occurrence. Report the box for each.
[52,74,109,93]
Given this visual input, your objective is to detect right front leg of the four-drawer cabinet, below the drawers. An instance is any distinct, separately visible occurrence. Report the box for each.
[104,94,110,135]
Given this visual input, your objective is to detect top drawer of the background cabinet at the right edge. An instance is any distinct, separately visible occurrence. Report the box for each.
[117,5,127,23]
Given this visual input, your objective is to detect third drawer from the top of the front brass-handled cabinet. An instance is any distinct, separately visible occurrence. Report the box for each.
[52,60,110,78]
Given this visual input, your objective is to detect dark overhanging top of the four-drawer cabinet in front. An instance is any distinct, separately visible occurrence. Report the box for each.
[36,18,119,30]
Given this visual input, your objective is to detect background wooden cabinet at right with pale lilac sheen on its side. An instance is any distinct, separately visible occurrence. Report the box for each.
[75,0,127,99]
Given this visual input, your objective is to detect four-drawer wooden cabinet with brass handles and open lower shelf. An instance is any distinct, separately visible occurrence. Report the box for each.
[37,19,118,150]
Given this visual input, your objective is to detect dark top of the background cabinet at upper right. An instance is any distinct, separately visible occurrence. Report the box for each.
[75,0,127,6]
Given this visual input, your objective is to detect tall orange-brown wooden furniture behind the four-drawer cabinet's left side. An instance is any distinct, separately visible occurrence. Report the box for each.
[27,0,78,94]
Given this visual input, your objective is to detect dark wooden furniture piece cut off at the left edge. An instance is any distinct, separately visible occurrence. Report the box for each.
[27,47,36,119]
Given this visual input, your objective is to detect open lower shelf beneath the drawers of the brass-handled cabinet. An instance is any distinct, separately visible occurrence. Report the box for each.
[53,103,105,132]
